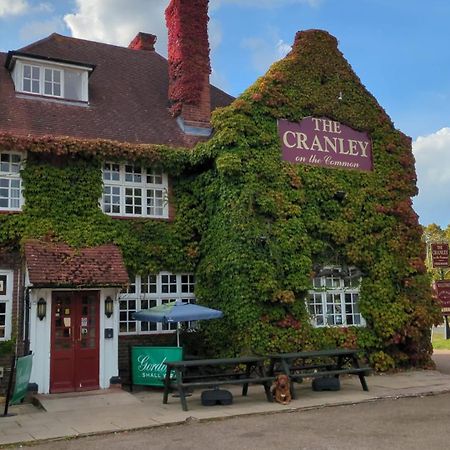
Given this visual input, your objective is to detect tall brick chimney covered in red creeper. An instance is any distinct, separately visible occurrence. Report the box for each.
[166,0,211,136]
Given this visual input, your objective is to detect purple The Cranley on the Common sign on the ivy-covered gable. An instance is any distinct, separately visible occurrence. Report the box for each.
[278,117,373,172]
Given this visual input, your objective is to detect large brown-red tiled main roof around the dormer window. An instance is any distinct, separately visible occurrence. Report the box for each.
[0,33,233,146]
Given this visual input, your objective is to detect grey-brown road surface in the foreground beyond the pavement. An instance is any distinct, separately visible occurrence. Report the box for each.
[16,394,450,450]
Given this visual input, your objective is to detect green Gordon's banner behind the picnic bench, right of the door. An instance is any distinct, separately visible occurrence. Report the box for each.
[131,347,183,386]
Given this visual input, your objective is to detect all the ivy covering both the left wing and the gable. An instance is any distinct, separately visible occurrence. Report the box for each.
[0,31,440,370]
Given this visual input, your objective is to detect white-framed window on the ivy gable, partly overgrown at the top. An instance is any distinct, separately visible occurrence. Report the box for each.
[307,267,366,327]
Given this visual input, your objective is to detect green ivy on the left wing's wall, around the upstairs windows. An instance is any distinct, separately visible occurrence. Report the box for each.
[0,137,198,273]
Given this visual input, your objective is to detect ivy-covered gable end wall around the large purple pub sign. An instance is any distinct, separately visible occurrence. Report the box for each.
[192,30,440,370]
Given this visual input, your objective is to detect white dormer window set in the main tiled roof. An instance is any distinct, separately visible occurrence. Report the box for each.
[6,52,94,102]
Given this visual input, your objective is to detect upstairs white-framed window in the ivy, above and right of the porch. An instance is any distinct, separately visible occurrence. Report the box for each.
[102,162,169,218]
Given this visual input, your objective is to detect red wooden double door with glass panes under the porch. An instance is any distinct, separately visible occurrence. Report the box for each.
[50,291,99,392]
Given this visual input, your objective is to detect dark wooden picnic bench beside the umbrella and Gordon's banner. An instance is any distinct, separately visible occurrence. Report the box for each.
[163,356,274,411]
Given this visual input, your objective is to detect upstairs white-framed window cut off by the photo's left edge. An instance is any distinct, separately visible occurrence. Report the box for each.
[0,151,23,211]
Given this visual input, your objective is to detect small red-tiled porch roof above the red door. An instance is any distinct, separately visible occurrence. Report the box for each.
[25,240,128,287]
